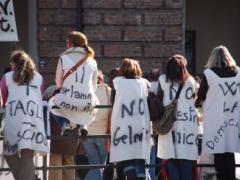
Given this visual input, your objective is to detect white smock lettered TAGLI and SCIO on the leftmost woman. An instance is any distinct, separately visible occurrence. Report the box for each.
[3,71,49,155]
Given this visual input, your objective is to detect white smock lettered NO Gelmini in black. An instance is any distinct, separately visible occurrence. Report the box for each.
[110,77,151,163]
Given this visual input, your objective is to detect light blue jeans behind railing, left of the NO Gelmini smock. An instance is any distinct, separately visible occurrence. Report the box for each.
[83,138,107,180]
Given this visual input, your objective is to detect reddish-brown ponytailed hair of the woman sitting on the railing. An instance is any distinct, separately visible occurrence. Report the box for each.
[68,31,95,57]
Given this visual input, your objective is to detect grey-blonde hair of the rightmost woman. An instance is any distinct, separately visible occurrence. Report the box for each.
[205,45,236,68]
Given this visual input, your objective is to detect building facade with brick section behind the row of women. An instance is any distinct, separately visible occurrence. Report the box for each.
[0,0,240,85]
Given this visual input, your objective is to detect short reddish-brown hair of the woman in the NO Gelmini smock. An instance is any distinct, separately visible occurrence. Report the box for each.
[119,58,142,77]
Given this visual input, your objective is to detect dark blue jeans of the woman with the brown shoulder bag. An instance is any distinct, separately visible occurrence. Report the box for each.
[167,159,194,180]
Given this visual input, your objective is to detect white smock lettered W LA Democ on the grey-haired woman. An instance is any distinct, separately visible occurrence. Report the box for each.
[202,69,240,153]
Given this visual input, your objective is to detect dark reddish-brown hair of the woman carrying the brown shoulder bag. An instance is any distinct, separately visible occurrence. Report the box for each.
[165,54,190,84]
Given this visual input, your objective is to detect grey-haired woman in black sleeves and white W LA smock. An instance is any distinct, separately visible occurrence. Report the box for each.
[195,46,240,180]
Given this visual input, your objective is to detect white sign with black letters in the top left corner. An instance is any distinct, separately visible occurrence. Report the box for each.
[0,0,18,42]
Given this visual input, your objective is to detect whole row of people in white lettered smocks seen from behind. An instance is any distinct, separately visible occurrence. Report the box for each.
[1,31,240,180]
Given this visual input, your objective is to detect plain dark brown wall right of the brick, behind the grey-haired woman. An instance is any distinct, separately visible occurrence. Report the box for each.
[186,0,240,73]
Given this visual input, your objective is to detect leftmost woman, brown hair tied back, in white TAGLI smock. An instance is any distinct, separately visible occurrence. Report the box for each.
[1,51,49,180]
